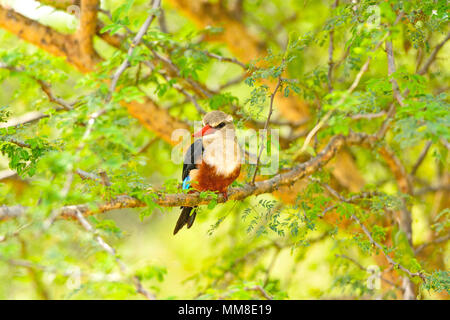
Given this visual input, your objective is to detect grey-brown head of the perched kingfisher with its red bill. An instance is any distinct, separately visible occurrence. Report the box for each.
[193,110,234,140]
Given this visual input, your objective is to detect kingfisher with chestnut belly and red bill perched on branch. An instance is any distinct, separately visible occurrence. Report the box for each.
[173,110,241,235]
